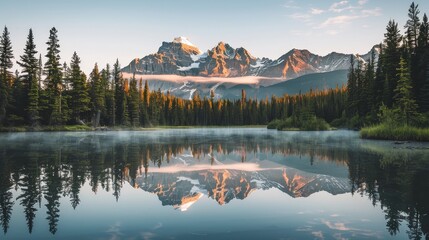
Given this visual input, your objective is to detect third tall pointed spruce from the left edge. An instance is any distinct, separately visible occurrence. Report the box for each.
[45,27,64,124]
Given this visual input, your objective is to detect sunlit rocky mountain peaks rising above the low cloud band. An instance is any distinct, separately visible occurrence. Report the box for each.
[122,37,378,80]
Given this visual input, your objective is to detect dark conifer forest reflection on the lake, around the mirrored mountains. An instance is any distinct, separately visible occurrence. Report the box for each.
[0,130,429,239]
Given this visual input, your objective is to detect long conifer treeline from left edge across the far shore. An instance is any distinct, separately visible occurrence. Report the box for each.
[0,27,346,127]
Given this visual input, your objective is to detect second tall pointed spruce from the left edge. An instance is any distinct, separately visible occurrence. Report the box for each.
[17,29,39,126]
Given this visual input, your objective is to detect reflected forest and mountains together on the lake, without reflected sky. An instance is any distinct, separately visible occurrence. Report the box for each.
[0,129,429,239]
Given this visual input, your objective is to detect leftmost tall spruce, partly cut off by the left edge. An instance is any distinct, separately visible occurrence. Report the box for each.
[0,26,14,125]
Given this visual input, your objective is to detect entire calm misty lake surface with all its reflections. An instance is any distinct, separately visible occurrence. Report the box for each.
[0,128,429,239]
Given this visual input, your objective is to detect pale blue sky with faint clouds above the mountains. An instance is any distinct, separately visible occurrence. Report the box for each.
[0,0,429,73]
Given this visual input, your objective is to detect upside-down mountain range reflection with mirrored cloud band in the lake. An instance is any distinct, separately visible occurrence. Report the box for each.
[134,154,351,211]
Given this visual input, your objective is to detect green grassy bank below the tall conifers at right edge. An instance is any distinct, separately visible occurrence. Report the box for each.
[360,124,429,141]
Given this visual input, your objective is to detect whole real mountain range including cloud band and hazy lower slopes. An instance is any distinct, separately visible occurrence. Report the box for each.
[122,37,379,99]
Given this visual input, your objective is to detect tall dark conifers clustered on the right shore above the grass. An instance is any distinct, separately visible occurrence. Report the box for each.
[347,2,429,126]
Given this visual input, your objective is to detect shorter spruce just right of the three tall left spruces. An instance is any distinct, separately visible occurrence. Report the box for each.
[70,52,90,123]
